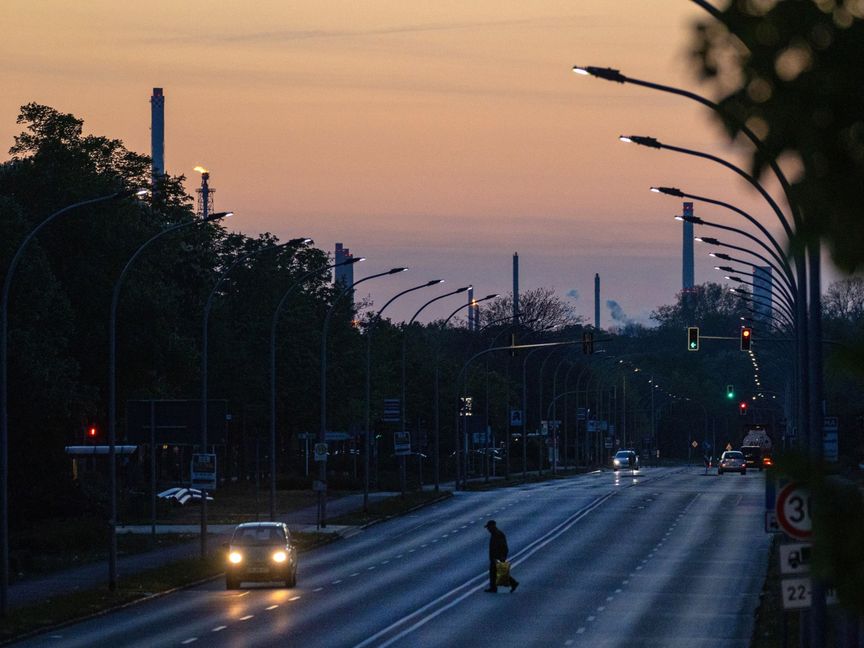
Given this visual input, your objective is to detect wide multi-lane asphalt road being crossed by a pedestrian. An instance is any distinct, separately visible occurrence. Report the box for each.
[16,467,769,648]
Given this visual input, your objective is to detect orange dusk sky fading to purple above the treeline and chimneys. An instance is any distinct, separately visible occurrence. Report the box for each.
[0,0,816,328]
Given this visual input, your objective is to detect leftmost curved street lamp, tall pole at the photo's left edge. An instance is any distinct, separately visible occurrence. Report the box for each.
[0,189,148,617]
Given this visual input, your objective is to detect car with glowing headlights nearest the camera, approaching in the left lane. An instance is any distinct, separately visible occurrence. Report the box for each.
[225,522,297,590]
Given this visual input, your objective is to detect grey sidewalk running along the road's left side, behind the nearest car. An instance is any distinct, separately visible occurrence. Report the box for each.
[9,492,398,609]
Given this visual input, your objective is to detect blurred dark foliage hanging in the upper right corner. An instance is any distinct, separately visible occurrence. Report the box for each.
[694,0,864,272]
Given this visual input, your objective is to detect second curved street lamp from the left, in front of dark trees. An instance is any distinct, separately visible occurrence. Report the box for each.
[108,212,234,592]
